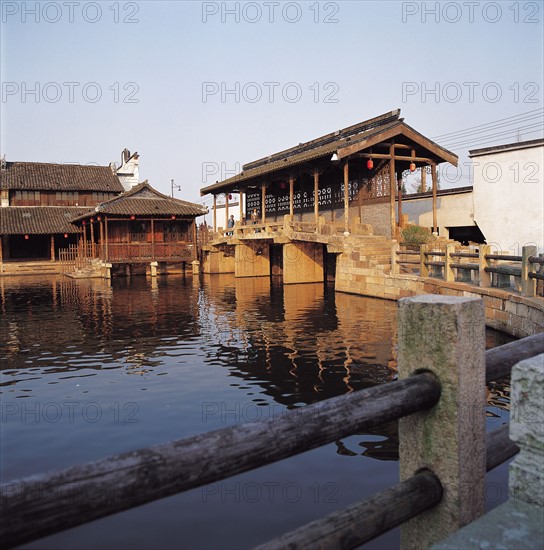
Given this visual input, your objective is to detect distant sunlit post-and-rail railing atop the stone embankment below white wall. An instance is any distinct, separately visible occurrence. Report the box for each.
[393,243,544,296]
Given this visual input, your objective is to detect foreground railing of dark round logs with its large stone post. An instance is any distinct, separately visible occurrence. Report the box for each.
[0,296,544,549]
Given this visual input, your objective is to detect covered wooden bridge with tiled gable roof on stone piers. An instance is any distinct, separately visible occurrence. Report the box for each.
[201,109,457,283]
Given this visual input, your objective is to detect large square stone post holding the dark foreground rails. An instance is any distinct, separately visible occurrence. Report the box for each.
[398,295,486,550]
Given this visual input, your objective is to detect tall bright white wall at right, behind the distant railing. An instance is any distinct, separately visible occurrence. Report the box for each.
[471,145,544,255]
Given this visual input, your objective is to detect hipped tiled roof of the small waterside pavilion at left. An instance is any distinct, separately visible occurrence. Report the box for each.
[73,181,207,219]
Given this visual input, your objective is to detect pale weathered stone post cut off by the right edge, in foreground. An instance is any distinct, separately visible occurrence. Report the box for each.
[508,356,544,506]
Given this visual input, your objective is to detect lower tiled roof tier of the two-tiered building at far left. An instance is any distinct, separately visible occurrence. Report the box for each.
[0,206,88,235]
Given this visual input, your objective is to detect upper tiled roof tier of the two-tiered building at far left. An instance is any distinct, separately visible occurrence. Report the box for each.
[0,162,124,193]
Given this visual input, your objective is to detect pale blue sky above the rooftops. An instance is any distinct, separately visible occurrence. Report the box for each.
[0,1,544,207]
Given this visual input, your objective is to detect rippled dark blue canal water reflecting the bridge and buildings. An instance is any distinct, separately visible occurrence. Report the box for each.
[0,275,509,549]
